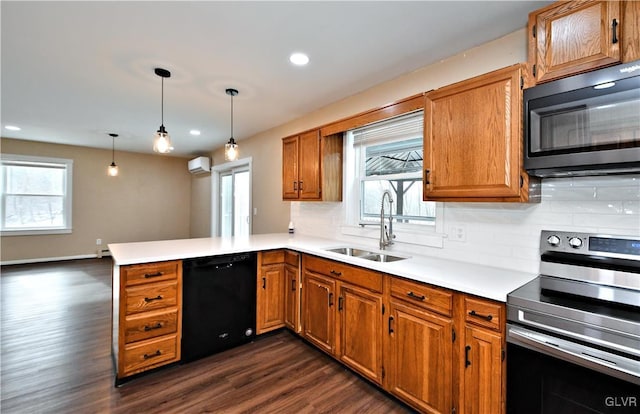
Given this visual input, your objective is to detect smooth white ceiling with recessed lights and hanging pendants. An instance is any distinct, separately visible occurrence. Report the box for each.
[0,1,550,157]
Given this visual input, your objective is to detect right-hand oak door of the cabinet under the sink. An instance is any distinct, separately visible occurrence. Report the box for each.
[338,284,383,384]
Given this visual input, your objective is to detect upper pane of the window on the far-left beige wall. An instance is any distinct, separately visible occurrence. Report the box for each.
[4,165,66,195]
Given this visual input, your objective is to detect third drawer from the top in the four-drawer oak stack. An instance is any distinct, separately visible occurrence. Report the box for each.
[124,309,178,343]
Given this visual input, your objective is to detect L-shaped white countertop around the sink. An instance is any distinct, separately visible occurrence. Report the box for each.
[109,233,537,302]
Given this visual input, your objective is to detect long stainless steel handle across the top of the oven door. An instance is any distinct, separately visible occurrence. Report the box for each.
[507,324,640,385]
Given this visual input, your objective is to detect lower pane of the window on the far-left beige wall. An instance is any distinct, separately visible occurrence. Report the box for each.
[5,195,65,229]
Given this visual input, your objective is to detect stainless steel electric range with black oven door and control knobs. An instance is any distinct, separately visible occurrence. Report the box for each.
[507,231,640,414]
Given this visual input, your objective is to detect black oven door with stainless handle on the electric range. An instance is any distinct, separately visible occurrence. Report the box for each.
[507,324,640,414]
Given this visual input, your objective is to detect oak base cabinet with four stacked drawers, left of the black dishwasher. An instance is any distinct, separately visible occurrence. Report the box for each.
[112,260,182,384]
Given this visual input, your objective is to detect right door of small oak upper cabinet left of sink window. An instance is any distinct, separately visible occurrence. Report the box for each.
[298,130,321,200]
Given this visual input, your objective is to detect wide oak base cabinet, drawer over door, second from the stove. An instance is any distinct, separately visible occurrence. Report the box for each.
[385,277,454,413]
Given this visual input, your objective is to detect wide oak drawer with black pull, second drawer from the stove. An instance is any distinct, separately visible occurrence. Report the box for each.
[391,277,453,316]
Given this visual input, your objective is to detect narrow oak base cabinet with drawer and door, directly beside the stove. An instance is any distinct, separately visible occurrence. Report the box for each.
[460,295,506,414]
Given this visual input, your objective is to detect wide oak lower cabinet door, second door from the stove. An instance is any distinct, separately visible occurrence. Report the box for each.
[387,302,453,413]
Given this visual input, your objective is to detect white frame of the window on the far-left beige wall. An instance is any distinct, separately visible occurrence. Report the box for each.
[0,154,73,236]
